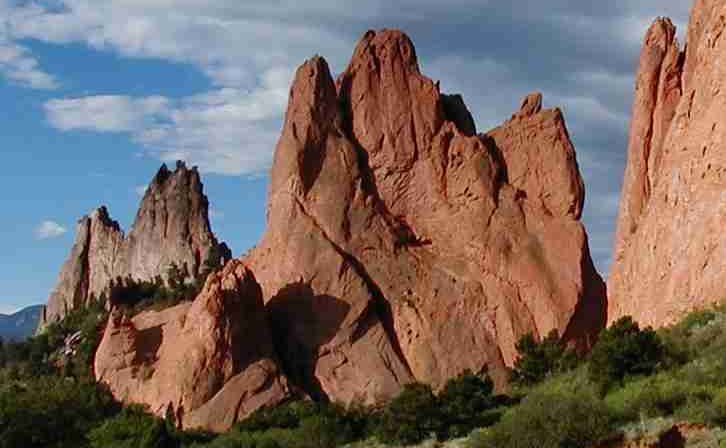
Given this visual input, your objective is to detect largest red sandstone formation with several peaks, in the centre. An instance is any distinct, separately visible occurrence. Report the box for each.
[244,31,606,404]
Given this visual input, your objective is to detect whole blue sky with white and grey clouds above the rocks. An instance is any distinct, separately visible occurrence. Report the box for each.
[0,0,689,312]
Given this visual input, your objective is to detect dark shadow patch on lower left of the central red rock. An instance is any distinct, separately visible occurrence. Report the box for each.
[266,282,350,400]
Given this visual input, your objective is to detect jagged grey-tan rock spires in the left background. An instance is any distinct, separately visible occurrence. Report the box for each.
[41,163,230,326]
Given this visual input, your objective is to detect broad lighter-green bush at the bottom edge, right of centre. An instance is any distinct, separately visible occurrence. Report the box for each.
[471,389,613,448]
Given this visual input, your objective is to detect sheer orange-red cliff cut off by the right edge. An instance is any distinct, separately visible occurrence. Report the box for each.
[608,0,726,326]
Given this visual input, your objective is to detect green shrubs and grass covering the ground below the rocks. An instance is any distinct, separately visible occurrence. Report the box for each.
[9,286,726,448]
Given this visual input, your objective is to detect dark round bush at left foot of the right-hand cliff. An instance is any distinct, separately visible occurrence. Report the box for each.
[589,317,665,392]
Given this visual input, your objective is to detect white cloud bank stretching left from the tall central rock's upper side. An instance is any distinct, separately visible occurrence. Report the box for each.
[45,67,292,174]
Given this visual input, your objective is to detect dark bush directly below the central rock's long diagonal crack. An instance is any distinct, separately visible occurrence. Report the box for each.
[376,383,443,445]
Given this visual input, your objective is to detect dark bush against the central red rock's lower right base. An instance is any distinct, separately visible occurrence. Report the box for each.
[511,330,578,386]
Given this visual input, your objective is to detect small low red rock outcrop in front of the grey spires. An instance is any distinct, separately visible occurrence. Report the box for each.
[94,261,291,431]
